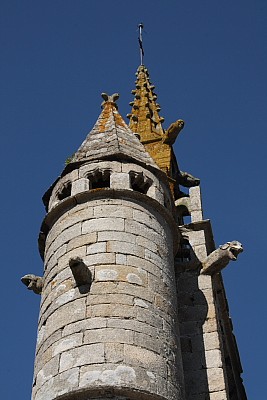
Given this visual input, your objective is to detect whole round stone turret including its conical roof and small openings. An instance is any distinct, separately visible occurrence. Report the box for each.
[32,97,184,400]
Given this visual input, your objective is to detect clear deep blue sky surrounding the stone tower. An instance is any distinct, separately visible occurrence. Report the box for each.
[0,0,267,400]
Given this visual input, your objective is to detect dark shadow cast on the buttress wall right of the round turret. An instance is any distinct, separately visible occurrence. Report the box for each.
[176,263,210,400]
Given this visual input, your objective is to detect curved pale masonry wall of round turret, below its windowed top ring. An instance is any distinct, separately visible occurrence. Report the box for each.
[32,197,183,400]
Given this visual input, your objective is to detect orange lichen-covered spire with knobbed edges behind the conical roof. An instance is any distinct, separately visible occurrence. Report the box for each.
[127,65,164,143]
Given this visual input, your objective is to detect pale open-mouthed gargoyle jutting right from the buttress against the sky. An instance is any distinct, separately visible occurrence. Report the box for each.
[200,240,243,275]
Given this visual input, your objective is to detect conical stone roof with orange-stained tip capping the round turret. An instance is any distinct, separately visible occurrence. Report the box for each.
[70,94,159,169]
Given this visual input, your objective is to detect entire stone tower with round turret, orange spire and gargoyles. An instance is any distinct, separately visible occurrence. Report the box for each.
[22,65,246,400]
